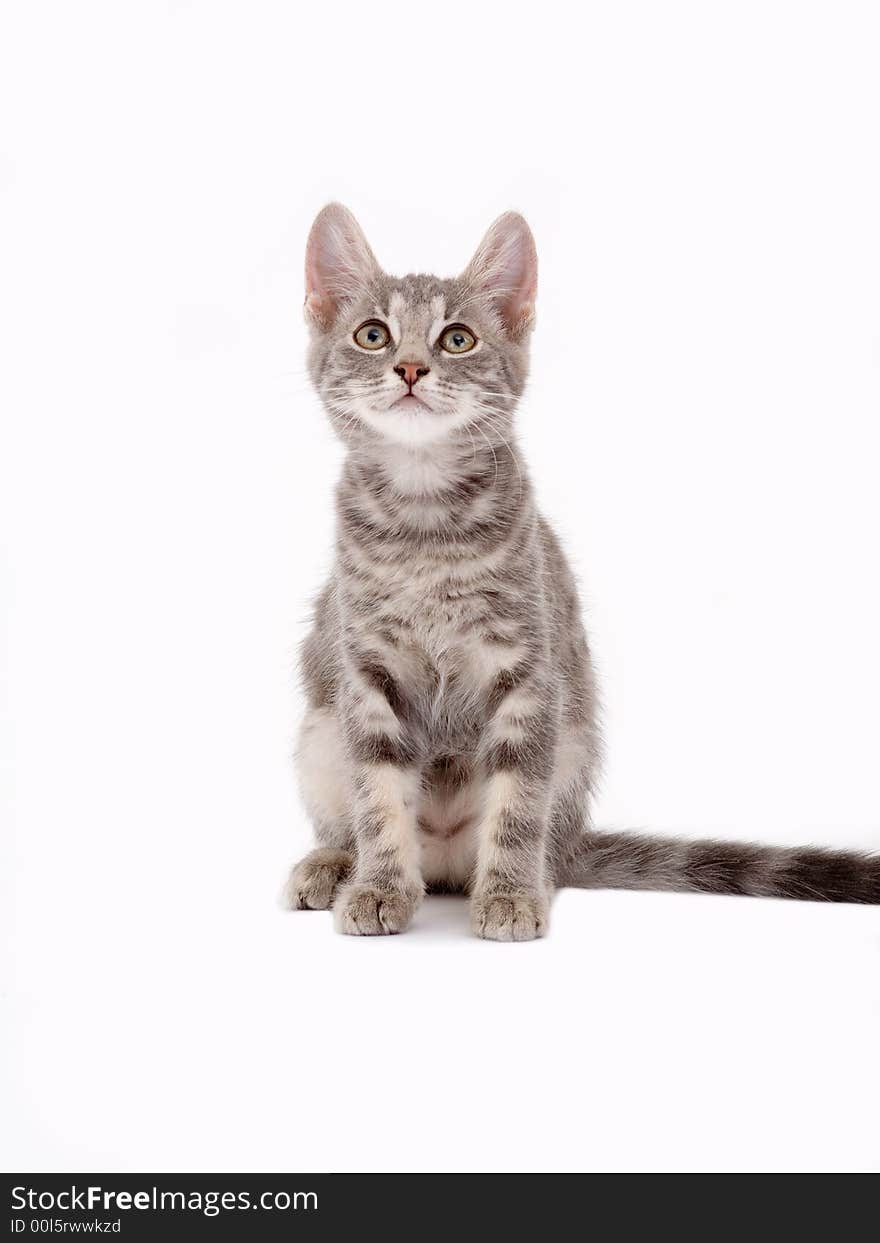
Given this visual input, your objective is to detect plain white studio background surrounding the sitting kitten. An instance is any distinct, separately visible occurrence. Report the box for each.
[0,0,880,1171]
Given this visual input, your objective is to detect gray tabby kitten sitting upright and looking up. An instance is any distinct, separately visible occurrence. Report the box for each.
[287,204,880,941]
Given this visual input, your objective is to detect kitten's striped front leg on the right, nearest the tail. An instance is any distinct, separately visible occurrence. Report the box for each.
[471,689,556,941]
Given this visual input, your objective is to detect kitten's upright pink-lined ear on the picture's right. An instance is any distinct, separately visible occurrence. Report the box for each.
[461,211,538,341]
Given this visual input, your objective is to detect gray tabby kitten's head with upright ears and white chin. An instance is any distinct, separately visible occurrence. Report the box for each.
[306,203,537,447]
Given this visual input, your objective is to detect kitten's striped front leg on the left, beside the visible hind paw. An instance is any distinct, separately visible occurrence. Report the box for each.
[333,664,424,936]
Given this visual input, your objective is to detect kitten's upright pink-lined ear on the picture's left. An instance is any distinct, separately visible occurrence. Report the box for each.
[306,203,379,332]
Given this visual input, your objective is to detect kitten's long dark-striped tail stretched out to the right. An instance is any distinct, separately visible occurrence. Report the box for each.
[559,833,880,904]
